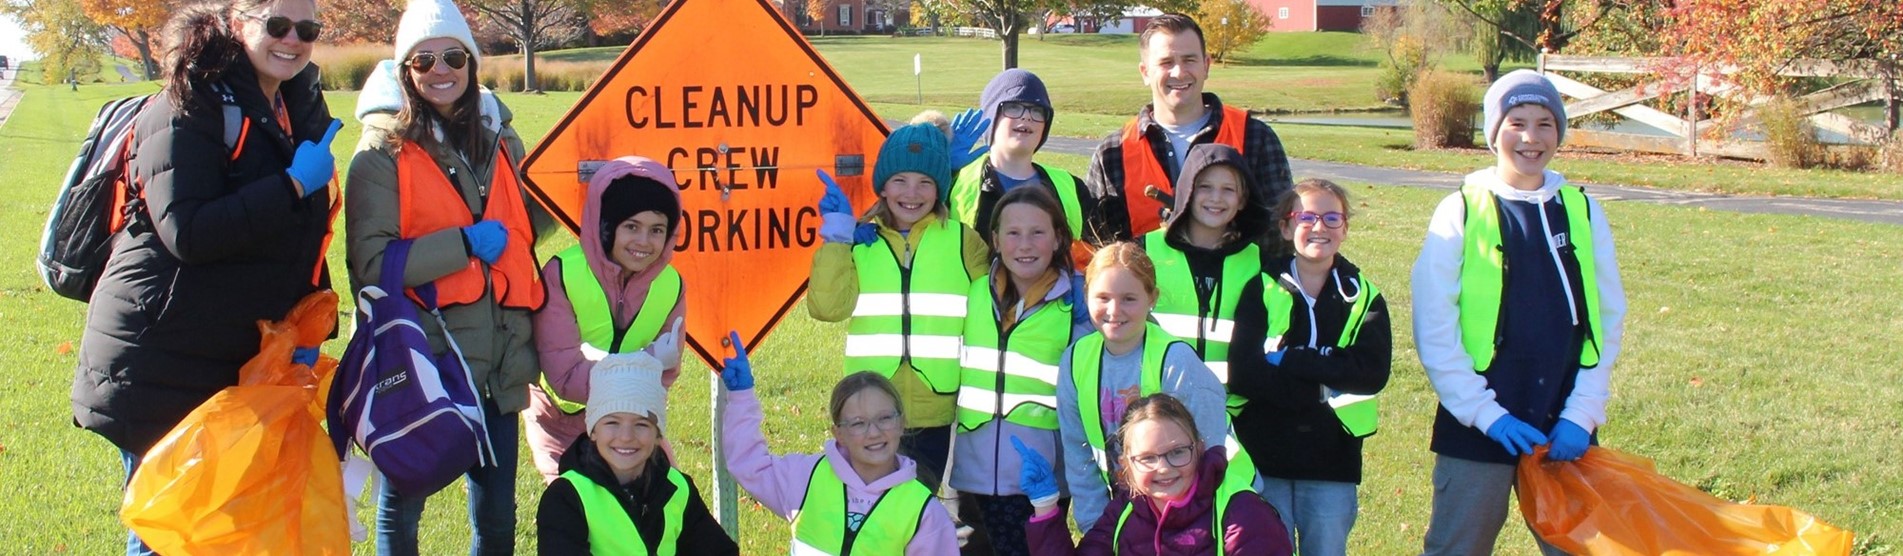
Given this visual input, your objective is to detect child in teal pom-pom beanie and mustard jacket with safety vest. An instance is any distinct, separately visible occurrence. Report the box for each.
[807,112,991,489]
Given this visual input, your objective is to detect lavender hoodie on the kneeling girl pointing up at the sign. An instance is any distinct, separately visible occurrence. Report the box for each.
[721,390,959,556]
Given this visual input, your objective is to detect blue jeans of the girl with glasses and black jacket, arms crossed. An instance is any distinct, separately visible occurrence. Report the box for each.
[1262,476,1361,556]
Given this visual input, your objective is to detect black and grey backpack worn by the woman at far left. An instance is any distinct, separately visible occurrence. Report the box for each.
[34,84,249,301]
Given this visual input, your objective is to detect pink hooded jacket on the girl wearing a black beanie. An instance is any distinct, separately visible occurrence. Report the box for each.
[521,156,687,484]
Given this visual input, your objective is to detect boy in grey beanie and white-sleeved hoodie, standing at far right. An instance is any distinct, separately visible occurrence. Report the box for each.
[1414,70,1625,554]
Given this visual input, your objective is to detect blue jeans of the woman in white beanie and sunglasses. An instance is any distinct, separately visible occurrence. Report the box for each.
[377,400,521,556]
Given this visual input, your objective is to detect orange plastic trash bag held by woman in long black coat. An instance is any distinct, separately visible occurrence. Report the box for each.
[120,291,350,554]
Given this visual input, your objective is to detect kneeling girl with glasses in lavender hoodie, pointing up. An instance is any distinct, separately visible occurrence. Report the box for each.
[721,333,959,556]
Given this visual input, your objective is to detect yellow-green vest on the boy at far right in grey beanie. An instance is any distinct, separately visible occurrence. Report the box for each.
[1460,185,1606,373]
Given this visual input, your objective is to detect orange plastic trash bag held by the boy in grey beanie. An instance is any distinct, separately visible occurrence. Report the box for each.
[1517,446,1852,556]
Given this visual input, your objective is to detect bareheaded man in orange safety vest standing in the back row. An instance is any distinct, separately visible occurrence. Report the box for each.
[1083,13,1294,253]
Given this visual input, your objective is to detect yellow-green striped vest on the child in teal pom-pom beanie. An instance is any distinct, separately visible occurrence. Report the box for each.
[845,221,971,394]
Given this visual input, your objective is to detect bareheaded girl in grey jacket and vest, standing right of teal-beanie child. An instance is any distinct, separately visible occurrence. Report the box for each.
[948,187,1090,556]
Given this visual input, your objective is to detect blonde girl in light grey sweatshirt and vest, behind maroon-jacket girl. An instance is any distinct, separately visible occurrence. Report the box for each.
[1058,242,1229,531]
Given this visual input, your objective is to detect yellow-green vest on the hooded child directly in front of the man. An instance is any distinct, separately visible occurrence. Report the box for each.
[1144,228,1262,417]
